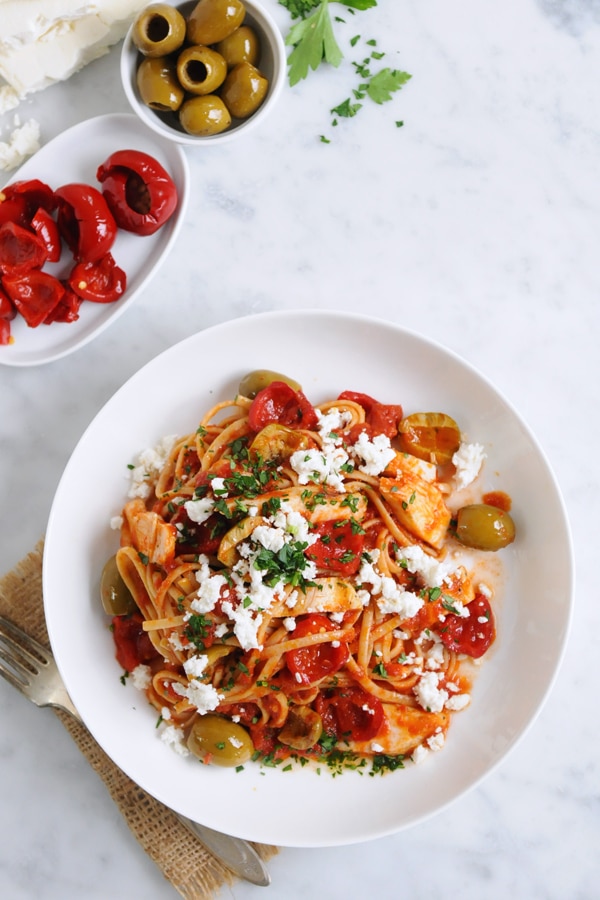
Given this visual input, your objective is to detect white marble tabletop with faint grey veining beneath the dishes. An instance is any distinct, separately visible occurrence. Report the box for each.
[0,0,600,900]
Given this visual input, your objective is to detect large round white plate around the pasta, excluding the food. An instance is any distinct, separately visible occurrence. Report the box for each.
[43,311,573,847]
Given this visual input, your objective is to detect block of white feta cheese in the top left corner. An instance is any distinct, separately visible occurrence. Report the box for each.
[0,0,148,113]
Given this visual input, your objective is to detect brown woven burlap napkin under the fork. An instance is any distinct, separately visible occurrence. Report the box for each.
[0,541,277,900]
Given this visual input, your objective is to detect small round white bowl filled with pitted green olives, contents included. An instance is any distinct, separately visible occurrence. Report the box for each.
[121,0,286,145]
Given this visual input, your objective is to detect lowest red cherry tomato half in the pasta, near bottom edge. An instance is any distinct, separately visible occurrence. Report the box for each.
[314,686,385,741]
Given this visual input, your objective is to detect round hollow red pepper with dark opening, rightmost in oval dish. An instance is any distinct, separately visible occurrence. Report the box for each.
[96,150,177,235]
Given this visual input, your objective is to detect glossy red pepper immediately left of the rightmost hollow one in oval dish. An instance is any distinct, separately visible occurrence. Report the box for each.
[55,184,117,262]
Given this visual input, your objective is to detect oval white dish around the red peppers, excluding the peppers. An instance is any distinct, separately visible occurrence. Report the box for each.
[0,113,189,366]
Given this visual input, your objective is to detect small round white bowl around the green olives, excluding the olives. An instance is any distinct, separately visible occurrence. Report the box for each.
[121,0,287,146]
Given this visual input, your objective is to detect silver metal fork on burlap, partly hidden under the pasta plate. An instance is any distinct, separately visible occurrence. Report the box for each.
[0,616,271,887]
